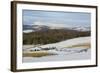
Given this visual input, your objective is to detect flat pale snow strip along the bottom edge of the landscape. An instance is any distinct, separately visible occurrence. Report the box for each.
[23,49,91,62]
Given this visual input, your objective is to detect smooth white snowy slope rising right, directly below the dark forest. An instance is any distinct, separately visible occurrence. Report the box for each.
[41,37,91,48]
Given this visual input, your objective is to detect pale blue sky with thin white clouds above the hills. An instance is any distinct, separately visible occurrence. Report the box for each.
[22,10,91,27]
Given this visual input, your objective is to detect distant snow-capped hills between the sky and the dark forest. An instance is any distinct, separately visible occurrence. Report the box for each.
[23,25,90,33]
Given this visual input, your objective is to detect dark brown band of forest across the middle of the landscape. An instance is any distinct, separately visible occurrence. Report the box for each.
[23,29,90,45]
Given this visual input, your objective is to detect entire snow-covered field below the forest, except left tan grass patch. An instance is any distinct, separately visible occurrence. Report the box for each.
[23,37,91,62]
